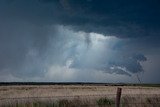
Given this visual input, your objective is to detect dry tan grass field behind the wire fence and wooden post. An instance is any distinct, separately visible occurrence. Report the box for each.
[0,85,160,107]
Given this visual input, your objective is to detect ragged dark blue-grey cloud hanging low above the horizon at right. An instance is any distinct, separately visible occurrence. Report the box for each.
[71,47,147,76]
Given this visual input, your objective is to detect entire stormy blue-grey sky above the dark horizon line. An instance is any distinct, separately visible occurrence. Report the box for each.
[0,0,160,83]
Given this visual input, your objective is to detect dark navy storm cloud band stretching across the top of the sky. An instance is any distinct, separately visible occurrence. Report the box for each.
[1,0,160,38]
